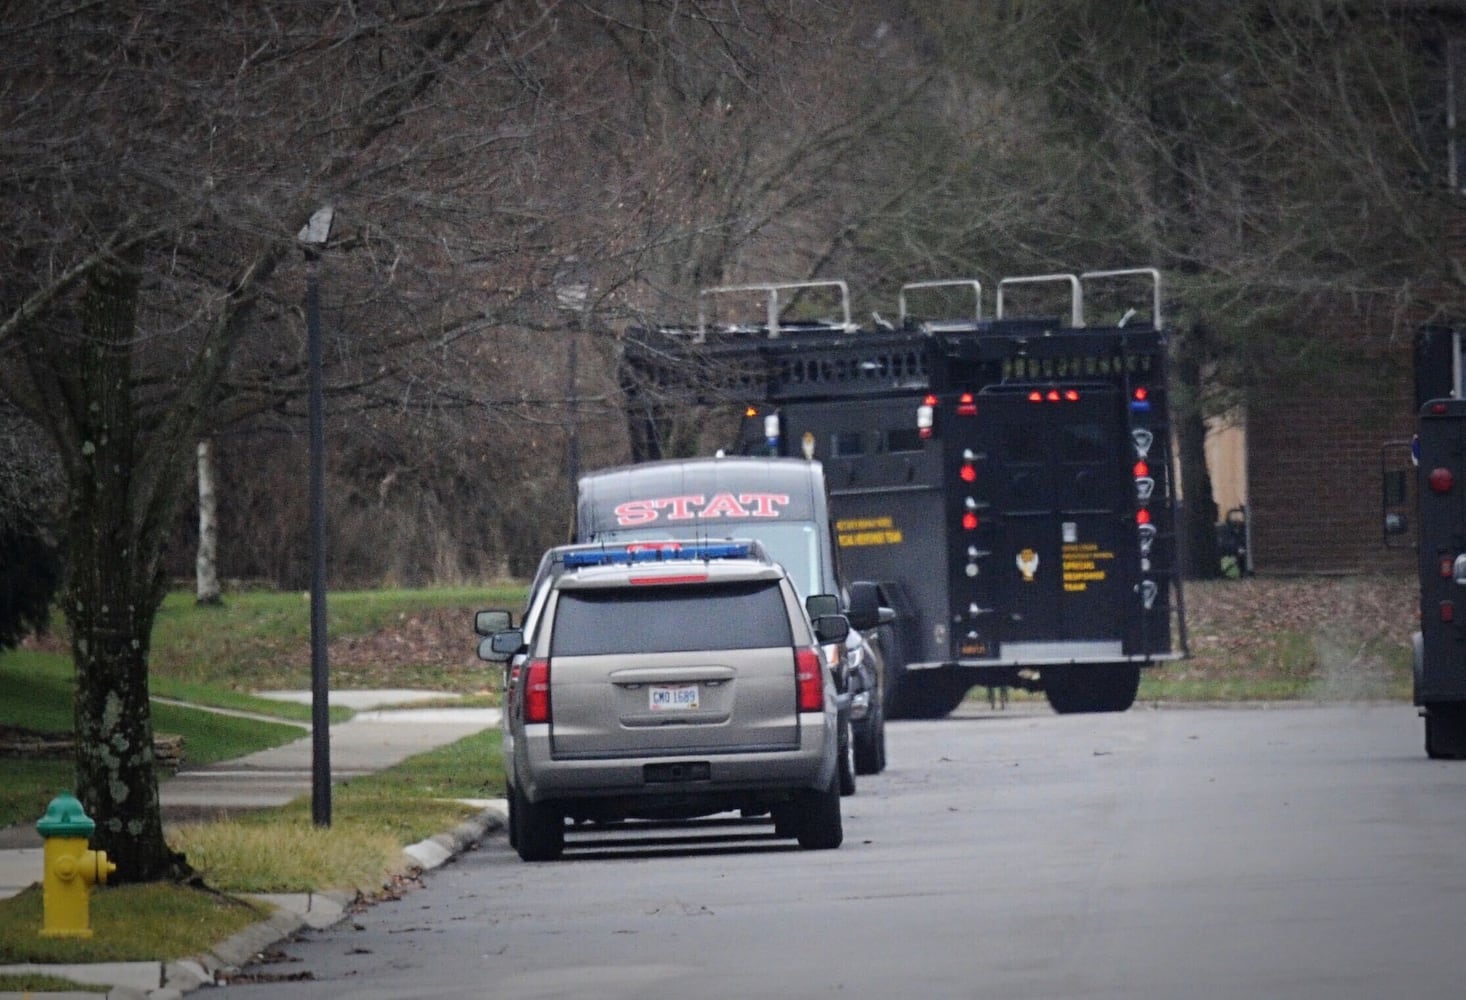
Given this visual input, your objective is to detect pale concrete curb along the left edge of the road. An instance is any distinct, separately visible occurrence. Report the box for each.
[0,799,507,1000]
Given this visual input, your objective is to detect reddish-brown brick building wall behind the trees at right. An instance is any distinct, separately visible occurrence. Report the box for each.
[1248,337,1415,573]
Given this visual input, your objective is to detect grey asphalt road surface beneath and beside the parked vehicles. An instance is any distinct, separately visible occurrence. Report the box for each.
[219,705,1466,1000]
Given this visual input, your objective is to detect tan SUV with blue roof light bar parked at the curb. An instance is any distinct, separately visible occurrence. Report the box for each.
[475,541,849,861]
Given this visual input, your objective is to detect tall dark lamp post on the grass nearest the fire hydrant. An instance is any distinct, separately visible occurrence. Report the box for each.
[298,205,336,827]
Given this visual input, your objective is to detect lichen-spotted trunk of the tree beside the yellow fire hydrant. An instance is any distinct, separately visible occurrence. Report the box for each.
[66,249,188,883]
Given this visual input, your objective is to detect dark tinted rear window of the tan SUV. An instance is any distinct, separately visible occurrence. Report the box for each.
[550,581,795,657]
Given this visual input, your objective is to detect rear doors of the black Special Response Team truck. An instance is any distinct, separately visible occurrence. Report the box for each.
[944,386,1135,660]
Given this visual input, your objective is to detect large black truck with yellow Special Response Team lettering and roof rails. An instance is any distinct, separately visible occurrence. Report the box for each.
[622,268,1186,718]
